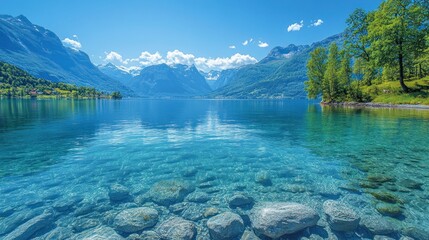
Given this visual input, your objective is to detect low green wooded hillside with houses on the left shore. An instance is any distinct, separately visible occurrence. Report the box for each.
[0,62,120,98]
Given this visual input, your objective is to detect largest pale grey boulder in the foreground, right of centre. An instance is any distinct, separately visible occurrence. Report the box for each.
[250,202,319,238]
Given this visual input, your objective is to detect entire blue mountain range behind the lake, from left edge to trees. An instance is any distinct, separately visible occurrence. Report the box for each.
[0,15,343,99]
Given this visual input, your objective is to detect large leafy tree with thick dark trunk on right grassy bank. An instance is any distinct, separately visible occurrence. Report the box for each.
[368,0,427,92]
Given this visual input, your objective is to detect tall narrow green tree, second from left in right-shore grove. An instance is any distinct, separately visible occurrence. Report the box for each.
[322,43,341,102]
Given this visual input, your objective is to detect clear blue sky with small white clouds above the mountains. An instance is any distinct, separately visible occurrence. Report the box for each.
[0,0,382,70]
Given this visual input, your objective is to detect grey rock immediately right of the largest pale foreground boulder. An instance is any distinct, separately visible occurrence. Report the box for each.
[323,200,360,232]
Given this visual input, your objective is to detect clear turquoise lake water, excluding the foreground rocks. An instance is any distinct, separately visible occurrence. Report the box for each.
[0,99,429,239]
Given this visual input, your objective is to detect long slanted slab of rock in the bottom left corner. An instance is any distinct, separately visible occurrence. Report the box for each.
[6,211,54,240]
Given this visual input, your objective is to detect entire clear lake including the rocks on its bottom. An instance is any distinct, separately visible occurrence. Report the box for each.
[0,100,429,240]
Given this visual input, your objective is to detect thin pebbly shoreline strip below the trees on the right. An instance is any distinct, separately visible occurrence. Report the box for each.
[320,102,429,110]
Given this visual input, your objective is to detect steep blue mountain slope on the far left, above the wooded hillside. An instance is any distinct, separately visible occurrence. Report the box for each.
[0,15,132,94]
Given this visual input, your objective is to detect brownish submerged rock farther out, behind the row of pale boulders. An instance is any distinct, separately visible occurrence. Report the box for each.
[148,180,195,206]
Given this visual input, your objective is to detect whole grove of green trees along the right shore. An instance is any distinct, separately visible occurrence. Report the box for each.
[305,0,429,103]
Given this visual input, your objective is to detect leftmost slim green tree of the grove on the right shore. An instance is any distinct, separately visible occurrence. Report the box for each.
[305,47,327,99]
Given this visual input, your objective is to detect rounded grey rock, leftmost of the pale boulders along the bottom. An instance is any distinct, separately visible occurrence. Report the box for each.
[113,207,158,233]
